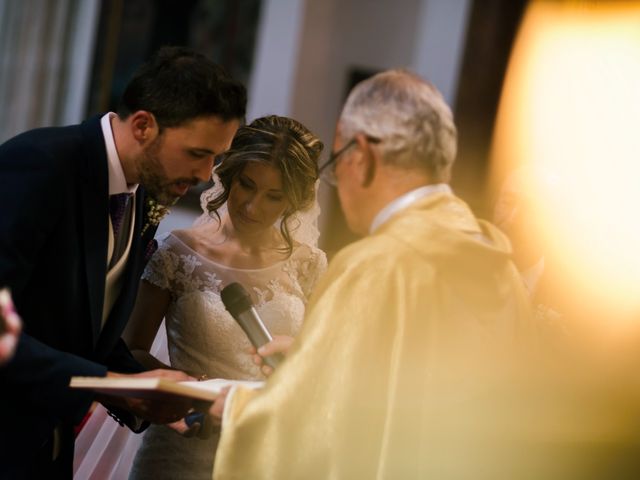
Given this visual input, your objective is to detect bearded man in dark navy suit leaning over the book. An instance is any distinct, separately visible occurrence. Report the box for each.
[0,48,246,478]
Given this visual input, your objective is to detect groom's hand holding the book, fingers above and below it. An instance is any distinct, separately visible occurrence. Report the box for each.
[98,369,195,423]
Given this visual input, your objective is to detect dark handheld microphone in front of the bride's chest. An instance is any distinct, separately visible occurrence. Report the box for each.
[220,283,284,369]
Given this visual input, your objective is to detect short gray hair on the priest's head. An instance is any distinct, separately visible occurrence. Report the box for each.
[340,70,457,182]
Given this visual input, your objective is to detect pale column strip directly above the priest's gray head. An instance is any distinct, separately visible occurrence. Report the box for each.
[413,0,472,108]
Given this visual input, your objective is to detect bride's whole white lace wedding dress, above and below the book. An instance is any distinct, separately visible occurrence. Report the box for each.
[125,234,326,480]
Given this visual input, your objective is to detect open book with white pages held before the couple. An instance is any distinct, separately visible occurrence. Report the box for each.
[69,377,264,402]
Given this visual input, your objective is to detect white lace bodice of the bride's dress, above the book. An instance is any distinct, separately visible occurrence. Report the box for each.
[143,234,326,380]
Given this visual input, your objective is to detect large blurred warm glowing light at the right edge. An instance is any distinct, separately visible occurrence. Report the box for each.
[492,1,640,318]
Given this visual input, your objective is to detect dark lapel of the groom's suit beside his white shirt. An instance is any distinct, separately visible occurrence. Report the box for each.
[81,117,109,345]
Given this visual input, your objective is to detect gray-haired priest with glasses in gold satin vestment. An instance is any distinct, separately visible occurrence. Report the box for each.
[212,70,532,479]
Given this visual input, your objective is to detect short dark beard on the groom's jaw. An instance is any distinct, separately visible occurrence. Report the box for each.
[138,137,199,206]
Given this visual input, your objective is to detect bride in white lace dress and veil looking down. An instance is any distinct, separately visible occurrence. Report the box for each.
[72,116,326,480]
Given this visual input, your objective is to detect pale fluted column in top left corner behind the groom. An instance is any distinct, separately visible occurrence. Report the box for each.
[0,0,100,142]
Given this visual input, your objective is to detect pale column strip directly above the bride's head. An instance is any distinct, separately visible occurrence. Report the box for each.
[247,0,305,121]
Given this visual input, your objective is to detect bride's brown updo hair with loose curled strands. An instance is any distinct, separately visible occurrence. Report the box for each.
[207,115,324,253]
